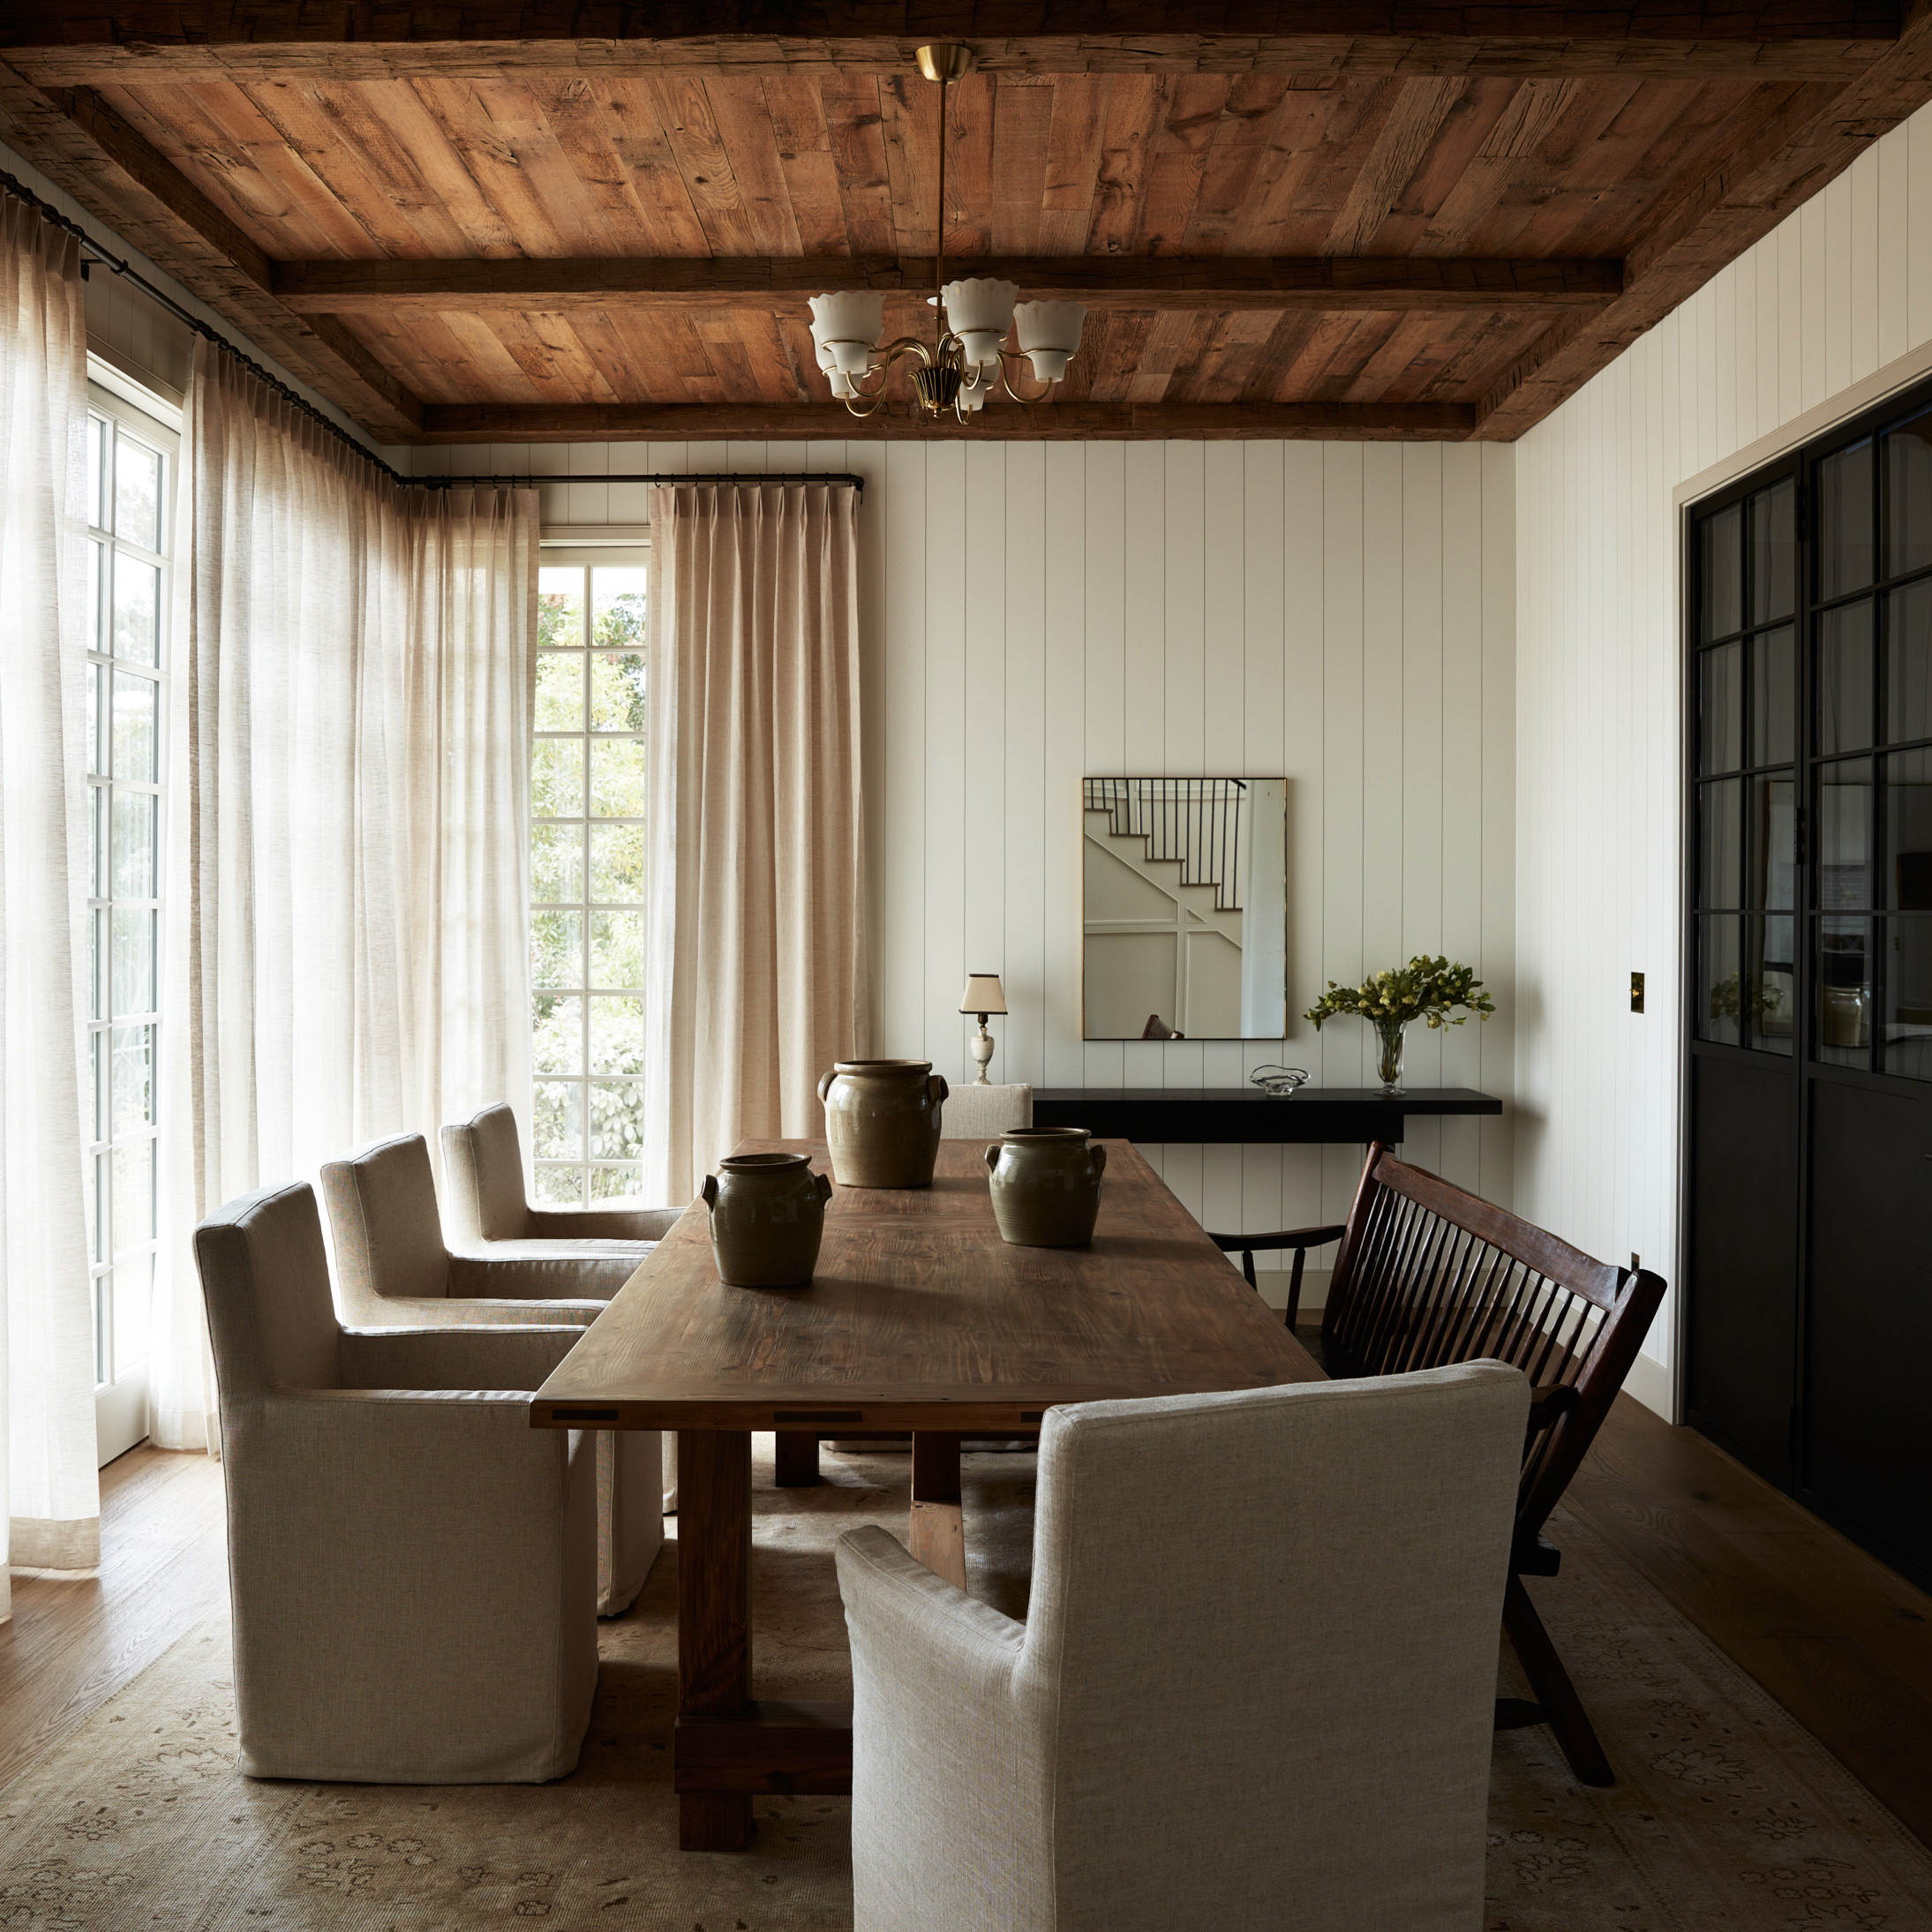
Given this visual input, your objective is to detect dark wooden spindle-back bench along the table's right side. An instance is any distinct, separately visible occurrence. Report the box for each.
[1209,1144,1664,1785]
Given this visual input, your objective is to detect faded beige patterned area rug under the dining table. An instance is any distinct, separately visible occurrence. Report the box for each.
[0,1440,1932,1932]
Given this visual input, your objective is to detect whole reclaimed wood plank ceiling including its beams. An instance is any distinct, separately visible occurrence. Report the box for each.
[0,0,1932,440]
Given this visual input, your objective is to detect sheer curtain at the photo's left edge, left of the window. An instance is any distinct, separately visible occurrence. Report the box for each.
[0,201,101,1619]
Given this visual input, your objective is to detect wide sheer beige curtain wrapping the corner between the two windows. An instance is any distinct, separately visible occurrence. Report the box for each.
[153,346,538,1447]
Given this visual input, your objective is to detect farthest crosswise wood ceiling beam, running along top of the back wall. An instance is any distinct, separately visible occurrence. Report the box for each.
[421,402,1476,442]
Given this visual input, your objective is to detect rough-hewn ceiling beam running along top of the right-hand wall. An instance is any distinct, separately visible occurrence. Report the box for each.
[1478,0,1932,440]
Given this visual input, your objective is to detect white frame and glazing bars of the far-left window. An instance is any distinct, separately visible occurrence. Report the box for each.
[81,369,182,1462]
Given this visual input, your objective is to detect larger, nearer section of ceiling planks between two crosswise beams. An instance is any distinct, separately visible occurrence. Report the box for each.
[101,73,1777,259]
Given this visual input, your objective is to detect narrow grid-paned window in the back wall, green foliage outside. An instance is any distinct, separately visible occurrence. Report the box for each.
[530,546,650,1204]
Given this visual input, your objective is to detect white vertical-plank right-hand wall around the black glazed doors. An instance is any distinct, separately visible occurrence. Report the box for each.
[1515,109,1932,1407]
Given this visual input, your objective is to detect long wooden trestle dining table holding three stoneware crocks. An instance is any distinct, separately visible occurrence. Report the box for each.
[530,1140,1321,1851]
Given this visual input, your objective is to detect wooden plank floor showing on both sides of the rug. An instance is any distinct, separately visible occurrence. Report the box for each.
[0,1397,1932,1843]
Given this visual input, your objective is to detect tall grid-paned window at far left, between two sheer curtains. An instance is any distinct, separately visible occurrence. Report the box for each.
[85,388,180,1457]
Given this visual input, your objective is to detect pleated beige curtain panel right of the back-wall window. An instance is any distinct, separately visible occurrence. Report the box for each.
[645,483,869,1202]
